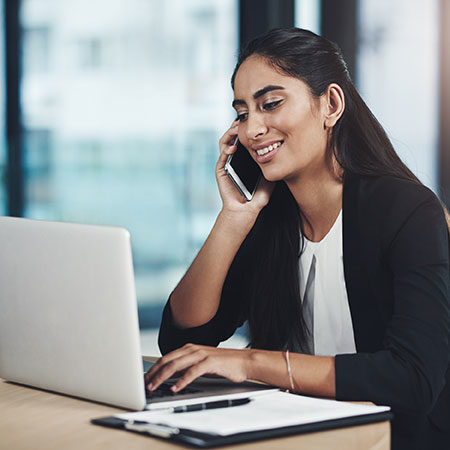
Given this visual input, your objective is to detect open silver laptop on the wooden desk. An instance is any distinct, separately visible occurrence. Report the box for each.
[0,217,274,410]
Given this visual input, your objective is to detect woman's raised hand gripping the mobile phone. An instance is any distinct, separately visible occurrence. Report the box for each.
[216,120,275,221]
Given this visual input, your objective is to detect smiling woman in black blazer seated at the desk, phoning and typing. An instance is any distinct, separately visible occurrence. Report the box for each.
[146,28,450,449]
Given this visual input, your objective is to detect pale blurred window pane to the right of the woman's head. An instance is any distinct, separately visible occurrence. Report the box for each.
[357,0,439,192]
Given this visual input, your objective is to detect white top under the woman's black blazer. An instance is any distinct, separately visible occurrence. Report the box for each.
[299,210,356,356]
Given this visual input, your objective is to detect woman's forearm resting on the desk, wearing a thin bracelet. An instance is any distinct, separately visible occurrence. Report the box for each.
[248,350,336,398]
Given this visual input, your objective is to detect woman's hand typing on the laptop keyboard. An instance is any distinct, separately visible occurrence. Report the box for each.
[145,344,251,392]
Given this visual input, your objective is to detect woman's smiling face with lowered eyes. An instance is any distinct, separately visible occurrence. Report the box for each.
[233,55,336,181]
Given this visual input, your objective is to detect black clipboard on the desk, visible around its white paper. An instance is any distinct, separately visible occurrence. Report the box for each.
[91,394,393,448]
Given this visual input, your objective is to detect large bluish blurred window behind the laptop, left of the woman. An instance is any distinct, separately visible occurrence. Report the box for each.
[21,0,238,326]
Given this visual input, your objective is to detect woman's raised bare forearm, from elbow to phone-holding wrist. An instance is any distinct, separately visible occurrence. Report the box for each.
[170,212,256,328]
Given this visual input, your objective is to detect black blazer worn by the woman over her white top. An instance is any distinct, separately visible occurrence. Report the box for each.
[159,174,450,449]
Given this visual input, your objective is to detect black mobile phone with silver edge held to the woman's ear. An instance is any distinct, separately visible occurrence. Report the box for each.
[225,138,262,202]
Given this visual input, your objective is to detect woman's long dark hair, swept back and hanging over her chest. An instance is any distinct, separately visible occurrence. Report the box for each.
[227,28,420,351]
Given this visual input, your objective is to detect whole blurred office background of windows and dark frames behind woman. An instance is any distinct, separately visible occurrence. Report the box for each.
[0,0,450,353]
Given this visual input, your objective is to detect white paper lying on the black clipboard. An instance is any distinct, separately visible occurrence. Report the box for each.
[115,391,390,436]
